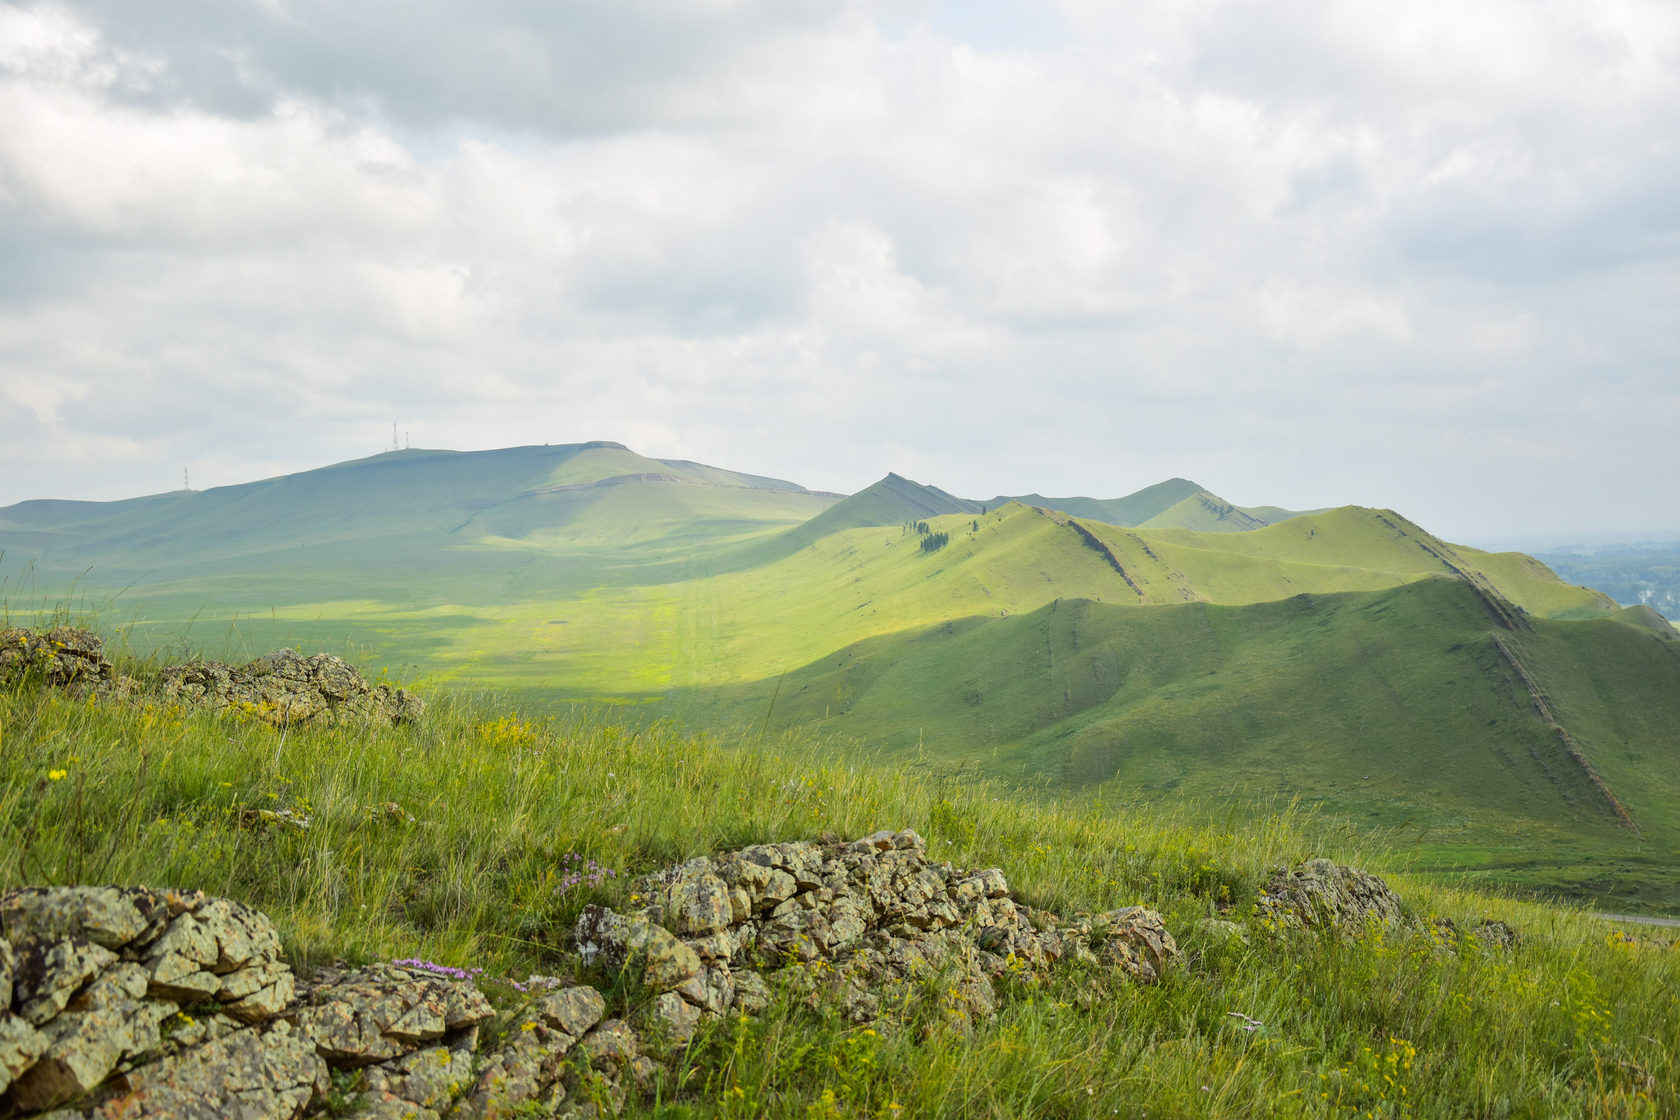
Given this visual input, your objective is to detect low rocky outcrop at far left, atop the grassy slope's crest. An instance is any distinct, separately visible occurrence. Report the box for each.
[0,626,425,727]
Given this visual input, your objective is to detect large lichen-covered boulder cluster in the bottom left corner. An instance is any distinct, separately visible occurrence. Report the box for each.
[0,887,302,1117]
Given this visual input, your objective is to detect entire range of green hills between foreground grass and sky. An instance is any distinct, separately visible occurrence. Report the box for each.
[0,442,1680,902]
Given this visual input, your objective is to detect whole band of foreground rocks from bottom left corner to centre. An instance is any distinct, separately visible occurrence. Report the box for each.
[0,831,1178,1120]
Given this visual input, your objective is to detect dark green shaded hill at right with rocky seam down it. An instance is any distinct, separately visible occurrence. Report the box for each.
[685,578,1680,908]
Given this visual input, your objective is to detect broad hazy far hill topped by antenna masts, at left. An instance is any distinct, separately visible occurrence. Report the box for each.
[0,443,838,578]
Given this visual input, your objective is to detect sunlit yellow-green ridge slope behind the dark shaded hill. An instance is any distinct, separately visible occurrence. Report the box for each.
[497,504,1613,695]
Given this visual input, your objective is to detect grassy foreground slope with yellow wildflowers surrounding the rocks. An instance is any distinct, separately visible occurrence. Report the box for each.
[0,661,1680,1117]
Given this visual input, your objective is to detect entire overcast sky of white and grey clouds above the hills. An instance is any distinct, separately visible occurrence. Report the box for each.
[0,0,1680,539]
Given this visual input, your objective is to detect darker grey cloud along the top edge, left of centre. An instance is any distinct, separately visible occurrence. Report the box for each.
[60,0,880,134]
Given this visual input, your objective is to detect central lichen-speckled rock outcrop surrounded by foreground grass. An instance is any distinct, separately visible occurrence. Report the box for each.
[573,830,1178,1043]
